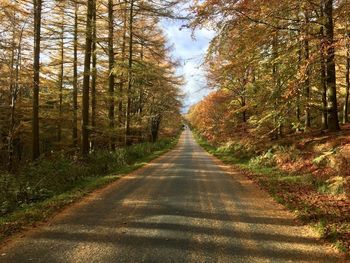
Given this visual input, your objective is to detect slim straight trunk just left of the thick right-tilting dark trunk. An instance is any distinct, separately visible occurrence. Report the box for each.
[72,0,79,146]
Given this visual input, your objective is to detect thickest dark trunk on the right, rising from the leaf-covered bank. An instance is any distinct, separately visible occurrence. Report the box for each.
[322,0,340,131]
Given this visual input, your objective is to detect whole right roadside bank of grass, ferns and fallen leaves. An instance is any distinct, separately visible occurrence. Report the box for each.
[195,129,350,255]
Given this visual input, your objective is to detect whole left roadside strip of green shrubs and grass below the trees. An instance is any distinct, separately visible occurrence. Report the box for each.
[0,136,178,243]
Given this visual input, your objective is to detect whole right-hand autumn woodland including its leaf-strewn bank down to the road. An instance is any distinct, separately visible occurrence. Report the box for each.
[186,0,350,254]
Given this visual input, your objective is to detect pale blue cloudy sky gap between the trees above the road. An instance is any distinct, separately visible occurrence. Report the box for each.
[162,20,214,113]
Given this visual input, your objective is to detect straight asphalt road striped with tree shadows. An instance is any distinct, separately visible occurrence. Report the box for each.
[0,130,339,263]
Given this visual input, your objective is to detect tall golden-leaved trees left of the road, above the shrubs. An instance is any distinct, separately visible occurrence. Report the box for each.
[0,0,182,170]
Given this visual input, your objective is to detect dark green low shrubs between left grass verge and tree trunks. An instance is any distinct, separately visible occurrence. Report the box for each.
[0,139,175,218]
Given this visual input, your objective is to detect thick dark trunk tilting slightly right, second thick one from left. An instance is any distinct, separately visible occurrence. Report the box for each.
[82,0,94,156]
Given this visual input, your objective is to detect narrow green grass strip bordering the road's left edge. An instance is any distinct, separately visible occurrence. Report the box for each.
[0,137,179,241]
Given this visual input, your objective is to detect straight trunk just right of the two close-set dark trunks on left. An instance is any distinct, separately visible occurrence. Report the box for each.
[108,0,115,151]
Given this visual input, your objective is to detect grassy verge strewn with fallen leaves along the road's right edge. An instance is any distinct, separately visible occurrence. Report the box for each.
[194,132,350,254]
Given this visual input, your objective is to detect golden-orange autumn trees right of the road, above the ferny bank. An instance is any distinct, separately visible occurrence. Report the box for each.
[190,1,350,139]
